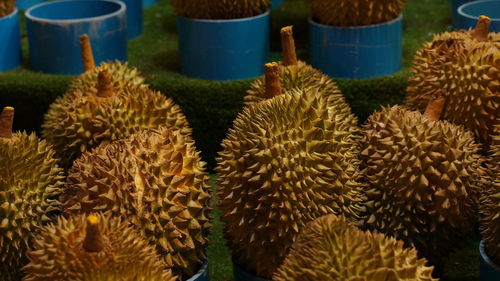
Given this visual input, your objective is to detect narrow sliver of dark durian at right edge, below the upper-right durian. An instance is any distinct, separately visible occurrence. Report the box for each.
[480,134,500,265]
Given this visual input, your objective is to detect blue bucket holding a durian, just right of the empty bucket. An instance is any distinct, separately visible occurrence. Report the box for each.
[177,11,270,81]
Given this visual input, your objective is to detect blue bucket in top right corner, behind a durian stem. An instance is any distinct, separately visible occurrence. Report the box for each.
[458,0,500,32]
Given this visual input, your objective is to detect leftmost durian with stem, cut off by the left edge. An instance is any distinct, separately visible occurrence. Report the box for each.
[0,107,64,281]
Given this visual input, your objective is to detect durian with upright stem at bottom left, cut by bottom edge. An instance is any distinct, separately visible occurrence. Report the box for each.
[23,214,177,281]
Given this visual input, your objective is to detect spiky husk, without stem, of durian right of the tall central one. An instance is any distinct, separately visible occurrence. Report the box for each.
[361,106,485,262]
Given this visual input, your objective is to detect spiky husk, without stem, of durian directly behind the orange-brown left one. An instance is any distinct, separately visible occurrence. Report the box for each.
[42,84,191,168]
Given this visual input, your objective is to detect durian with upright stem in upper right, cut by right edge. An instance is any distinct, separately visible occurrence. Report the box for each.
[405,17,500,149]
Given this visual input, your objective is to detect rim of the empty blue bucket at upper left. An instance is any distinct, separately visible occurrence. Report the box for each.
[25,0,127,24]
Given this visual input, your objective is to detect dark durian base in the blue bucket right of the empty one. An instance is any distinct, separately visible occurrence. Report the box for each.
[171,0,271,19]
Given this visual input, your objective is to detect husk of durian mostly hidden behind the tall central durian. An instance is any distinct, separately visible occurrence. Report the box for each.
[244,61,357,123]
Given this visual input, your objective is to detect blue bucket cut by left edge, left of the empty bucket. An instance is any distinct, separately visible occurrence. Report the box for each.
[0,9,21,71]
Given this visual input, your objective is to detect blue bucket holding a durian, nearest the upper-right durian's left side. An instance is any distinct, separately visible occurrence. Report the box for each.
[309,15,403,78]
